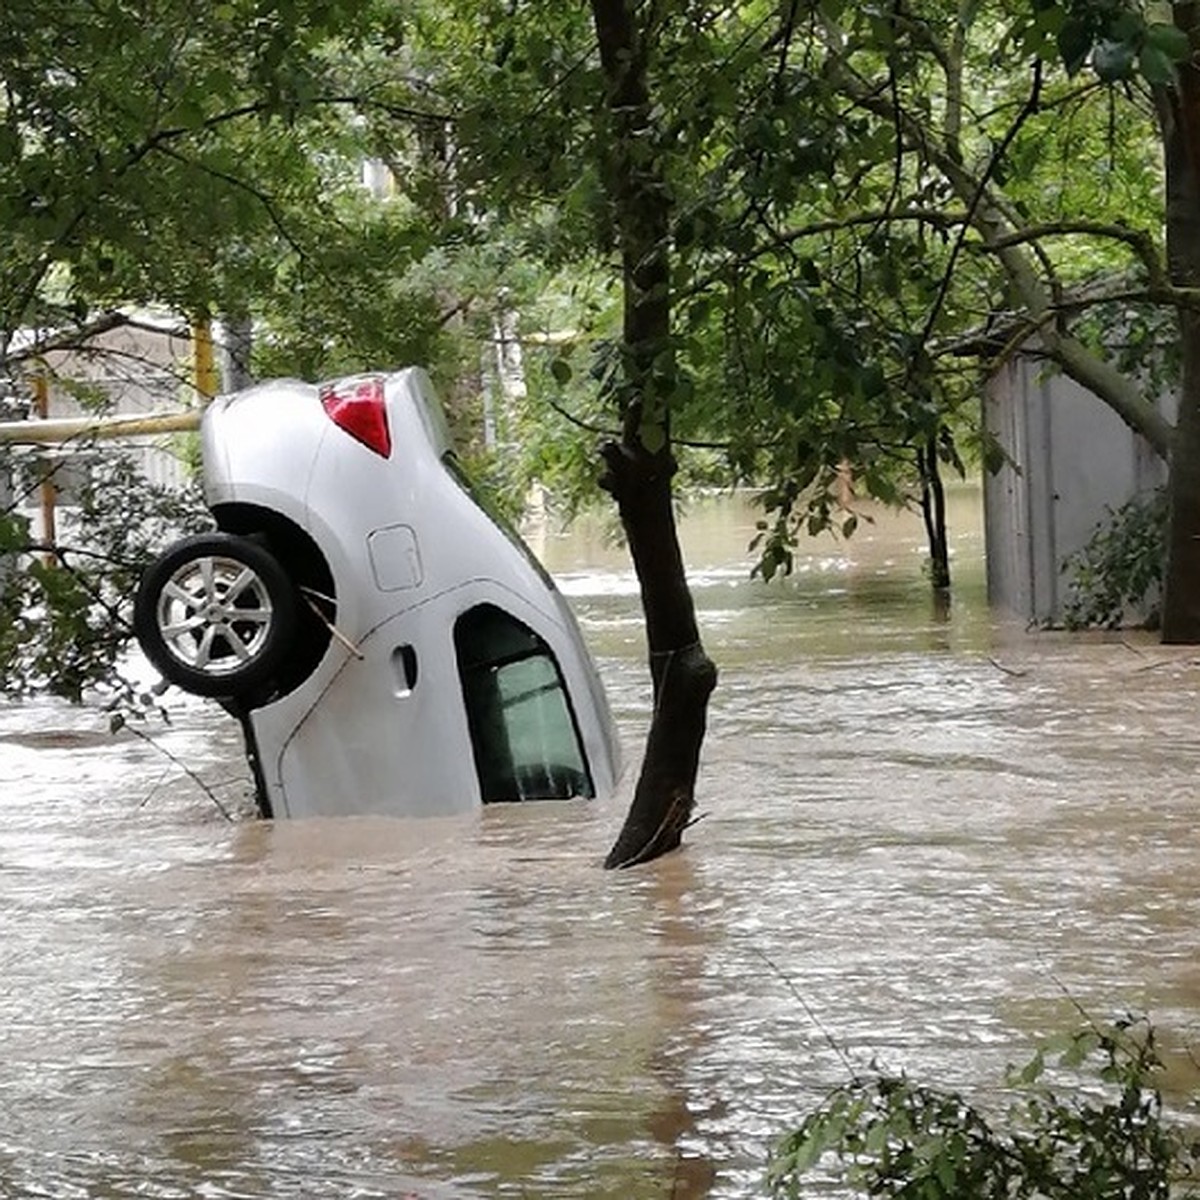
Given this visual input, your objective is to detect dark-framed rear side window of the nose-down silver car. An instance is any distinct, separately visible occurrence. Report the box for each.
[454,605,595,804]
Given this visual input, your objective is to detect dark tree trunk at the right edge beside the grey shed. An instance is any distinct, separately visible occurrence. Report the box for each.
[1159,4,1200,643]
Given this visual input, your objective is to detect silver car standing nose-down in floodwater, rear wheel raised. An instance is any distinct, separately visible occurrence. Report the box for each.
[134,367,618,817]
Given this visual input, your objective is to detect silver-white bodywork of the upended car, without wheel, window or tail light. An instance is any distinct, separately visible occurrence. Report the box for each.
[202,368,618,817]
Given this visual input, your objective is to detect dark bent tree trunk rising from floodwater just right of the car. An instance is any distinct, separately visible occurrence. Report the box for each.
[592,0,716,868]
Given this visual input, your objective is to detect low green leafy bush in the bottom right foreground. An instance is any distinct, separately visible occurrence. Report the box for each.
[769,1018,1200,1200]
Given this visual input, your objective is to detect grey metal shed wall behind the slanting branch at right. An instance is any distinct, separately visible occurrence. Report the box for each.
[984,356,1166,623]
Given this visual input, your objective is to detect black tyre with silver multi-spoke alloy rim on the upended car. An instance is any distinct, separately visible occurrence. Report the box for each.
[133,533,296,698]
